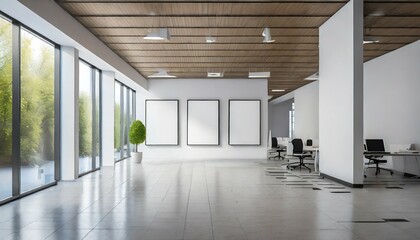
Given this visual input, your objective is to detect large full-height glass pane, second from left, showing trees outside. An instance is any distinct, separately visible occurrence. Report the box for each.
[20,29,55,192]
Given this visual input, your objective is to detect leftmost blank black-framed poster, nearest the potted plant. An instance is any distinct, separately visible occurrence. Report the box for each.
[145,99,179,146]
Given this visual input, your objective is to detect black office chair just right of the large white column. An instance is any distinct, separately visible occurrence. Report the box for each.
[364,139,394,177]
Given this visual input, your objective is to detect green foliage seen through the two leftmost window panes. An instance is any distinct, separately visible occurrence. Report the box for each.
[0,22,55,165]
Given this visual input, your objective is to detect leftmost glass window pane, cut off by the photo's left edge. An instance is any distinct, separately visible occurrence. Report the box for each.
[0,17,12,200]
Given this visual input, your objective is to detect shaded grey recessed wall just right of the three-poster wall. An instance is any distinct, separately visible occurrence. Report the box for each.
[268,99,294,137]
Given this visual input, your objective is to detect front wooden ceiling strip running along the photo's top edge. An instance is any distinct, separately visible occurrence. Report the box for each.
[60,2,343,16]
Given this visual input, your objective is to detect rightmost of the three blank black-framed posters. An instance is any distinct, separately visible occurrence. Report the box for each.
[228,99,261,146]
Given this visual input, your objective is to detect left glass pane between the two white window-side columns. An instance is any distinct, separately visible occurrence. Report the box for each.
[79,61,93,174]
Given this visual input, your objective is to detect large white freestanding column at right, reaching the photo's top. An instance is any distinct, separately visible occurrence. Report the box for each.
[319,0,363,186]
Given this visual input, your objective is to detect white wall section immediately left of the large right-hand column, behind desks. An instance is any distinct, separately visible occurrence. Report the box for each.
[294,81,319,141]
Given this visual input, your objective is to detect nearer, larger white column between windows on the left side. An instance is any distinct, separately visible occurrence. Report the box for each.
[60,46,79,181]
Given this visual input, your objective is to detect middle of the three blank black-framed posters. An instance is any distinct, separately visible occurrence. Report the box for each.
[187,99,220,146]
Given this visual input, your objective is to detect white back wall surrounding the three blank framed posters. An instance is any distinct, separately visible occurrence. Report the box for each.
[137,79,268,161]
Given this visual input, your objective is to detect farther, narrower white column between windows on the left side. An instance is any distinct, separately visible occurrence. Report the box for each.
[102,71,115,167]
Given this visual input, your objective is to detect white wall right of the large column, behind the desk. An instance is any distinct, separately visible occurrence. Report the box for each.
[364,41,420,174]
